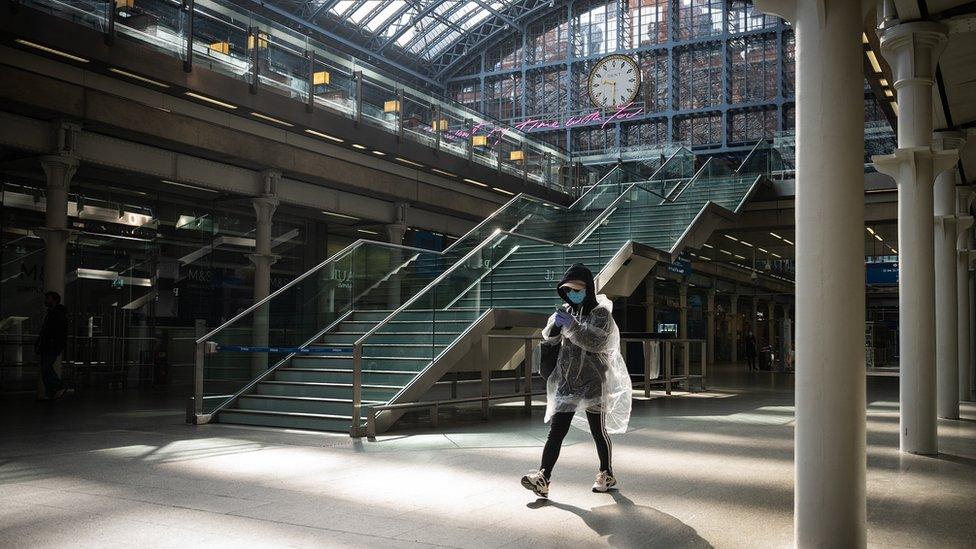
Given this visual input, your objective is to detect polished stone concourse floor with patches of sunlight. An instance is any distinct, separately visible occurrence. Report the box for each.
[0,366,976,548]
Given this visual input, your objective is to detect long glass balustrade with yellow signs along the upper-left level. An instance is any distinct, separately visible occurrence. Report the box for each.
[24,0,573,193]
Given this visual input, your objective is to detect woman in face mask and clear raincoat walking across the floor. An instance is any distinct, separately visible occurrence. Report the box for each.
[522,263,631,498]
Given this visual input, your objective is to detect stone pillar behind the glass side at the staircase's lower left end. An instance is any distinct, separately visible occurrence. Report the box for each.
[247,171,281,376]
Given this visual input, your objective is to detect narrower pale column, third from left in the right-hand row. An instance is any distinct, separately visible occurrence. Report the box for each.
[932,132,971,419]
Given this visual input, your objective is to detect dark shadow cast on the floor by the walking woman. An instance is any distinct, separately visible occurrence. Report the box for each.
[527,490,712,549]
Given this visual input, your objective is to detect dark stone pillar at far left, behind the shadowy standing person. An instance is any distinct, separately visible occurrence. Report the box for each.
[34,154,78,398]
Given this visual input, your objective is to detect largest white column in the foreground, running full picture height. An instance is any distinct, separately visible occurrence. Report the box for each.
[755,0,868,548]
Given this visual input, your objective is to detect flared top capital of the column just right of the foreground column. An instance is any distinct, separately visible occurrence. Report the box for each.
[881,21,949,90]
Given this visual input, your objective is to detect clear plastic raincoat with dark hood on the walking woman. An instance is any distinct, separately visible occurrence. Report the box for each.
[542,264,632,433]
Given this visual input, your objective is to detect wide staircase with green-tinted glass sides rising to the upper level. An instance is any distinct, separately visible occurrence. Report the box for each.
[197,142,775,433]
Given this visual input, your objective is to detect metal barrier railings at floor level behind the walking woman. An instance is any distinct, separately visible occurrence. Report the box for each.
[366,334,707,438]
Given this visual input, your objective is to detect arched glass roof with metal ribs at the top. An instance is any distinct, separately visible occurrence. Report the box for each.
[236,0,565,84]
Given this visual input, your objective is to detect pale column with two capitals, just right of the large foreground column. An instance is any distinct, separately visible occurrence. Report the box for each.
[872,21,954,454]
